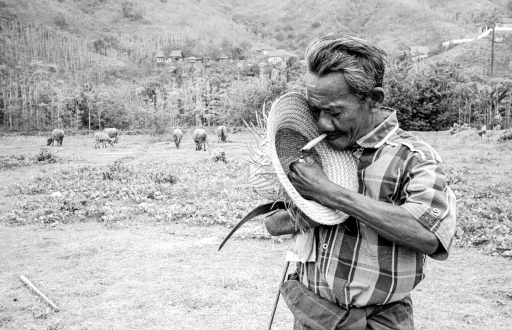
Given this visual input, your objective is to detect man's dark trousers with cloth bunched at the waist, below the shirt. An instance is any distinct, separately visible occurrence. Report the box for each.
[280,280,414,330]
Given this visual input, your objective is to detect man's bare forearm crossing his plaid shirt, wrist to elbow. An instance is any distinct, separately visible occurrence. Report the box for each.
[318,183,439,255]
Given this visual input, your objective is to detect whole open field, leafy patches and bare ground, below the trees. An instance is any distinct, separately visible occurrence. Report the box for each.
[0,131,512,330]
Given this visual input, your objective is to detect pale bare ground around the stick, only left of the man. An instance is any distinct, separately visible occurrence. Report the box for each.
[0,223,290,329]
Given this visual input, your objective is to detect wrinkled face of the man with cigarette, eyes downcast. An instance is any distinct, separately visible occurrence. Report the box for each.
[306,72,374,149]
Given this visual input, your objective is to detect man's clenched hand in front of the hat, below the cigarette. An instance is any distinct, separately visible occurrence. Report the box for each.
[288,157,331,203]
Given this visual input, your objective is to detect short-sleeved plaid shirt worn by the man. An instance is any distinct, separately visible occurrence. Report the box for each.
[297,110,455,308]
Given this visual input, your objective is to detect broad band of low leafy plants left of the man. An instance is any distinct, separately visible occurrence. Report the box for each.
[4,159,268,229]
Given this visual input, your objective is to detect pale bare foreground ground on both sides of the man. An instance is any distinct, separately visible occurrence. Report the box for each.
[0,223,512,330]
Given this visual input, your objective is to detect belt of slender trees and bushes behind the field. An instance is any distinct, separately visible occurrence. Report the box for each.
[0,21,512,132]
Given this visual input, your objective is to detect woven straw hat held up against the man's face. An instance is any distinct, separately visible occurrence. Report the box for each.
[267,93,358,225]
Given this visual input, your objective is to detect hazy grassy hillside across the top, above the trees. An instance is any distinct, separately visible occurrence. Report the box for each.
[0,0,512,59]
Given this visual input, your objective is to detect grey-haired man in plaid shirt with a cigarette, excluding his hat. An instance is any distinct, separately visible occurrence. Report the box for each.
[265,33,455,330]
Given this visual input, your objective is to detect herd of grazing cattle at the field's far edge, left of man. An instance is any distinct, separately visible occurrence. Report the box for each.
[47,126,228,151]
